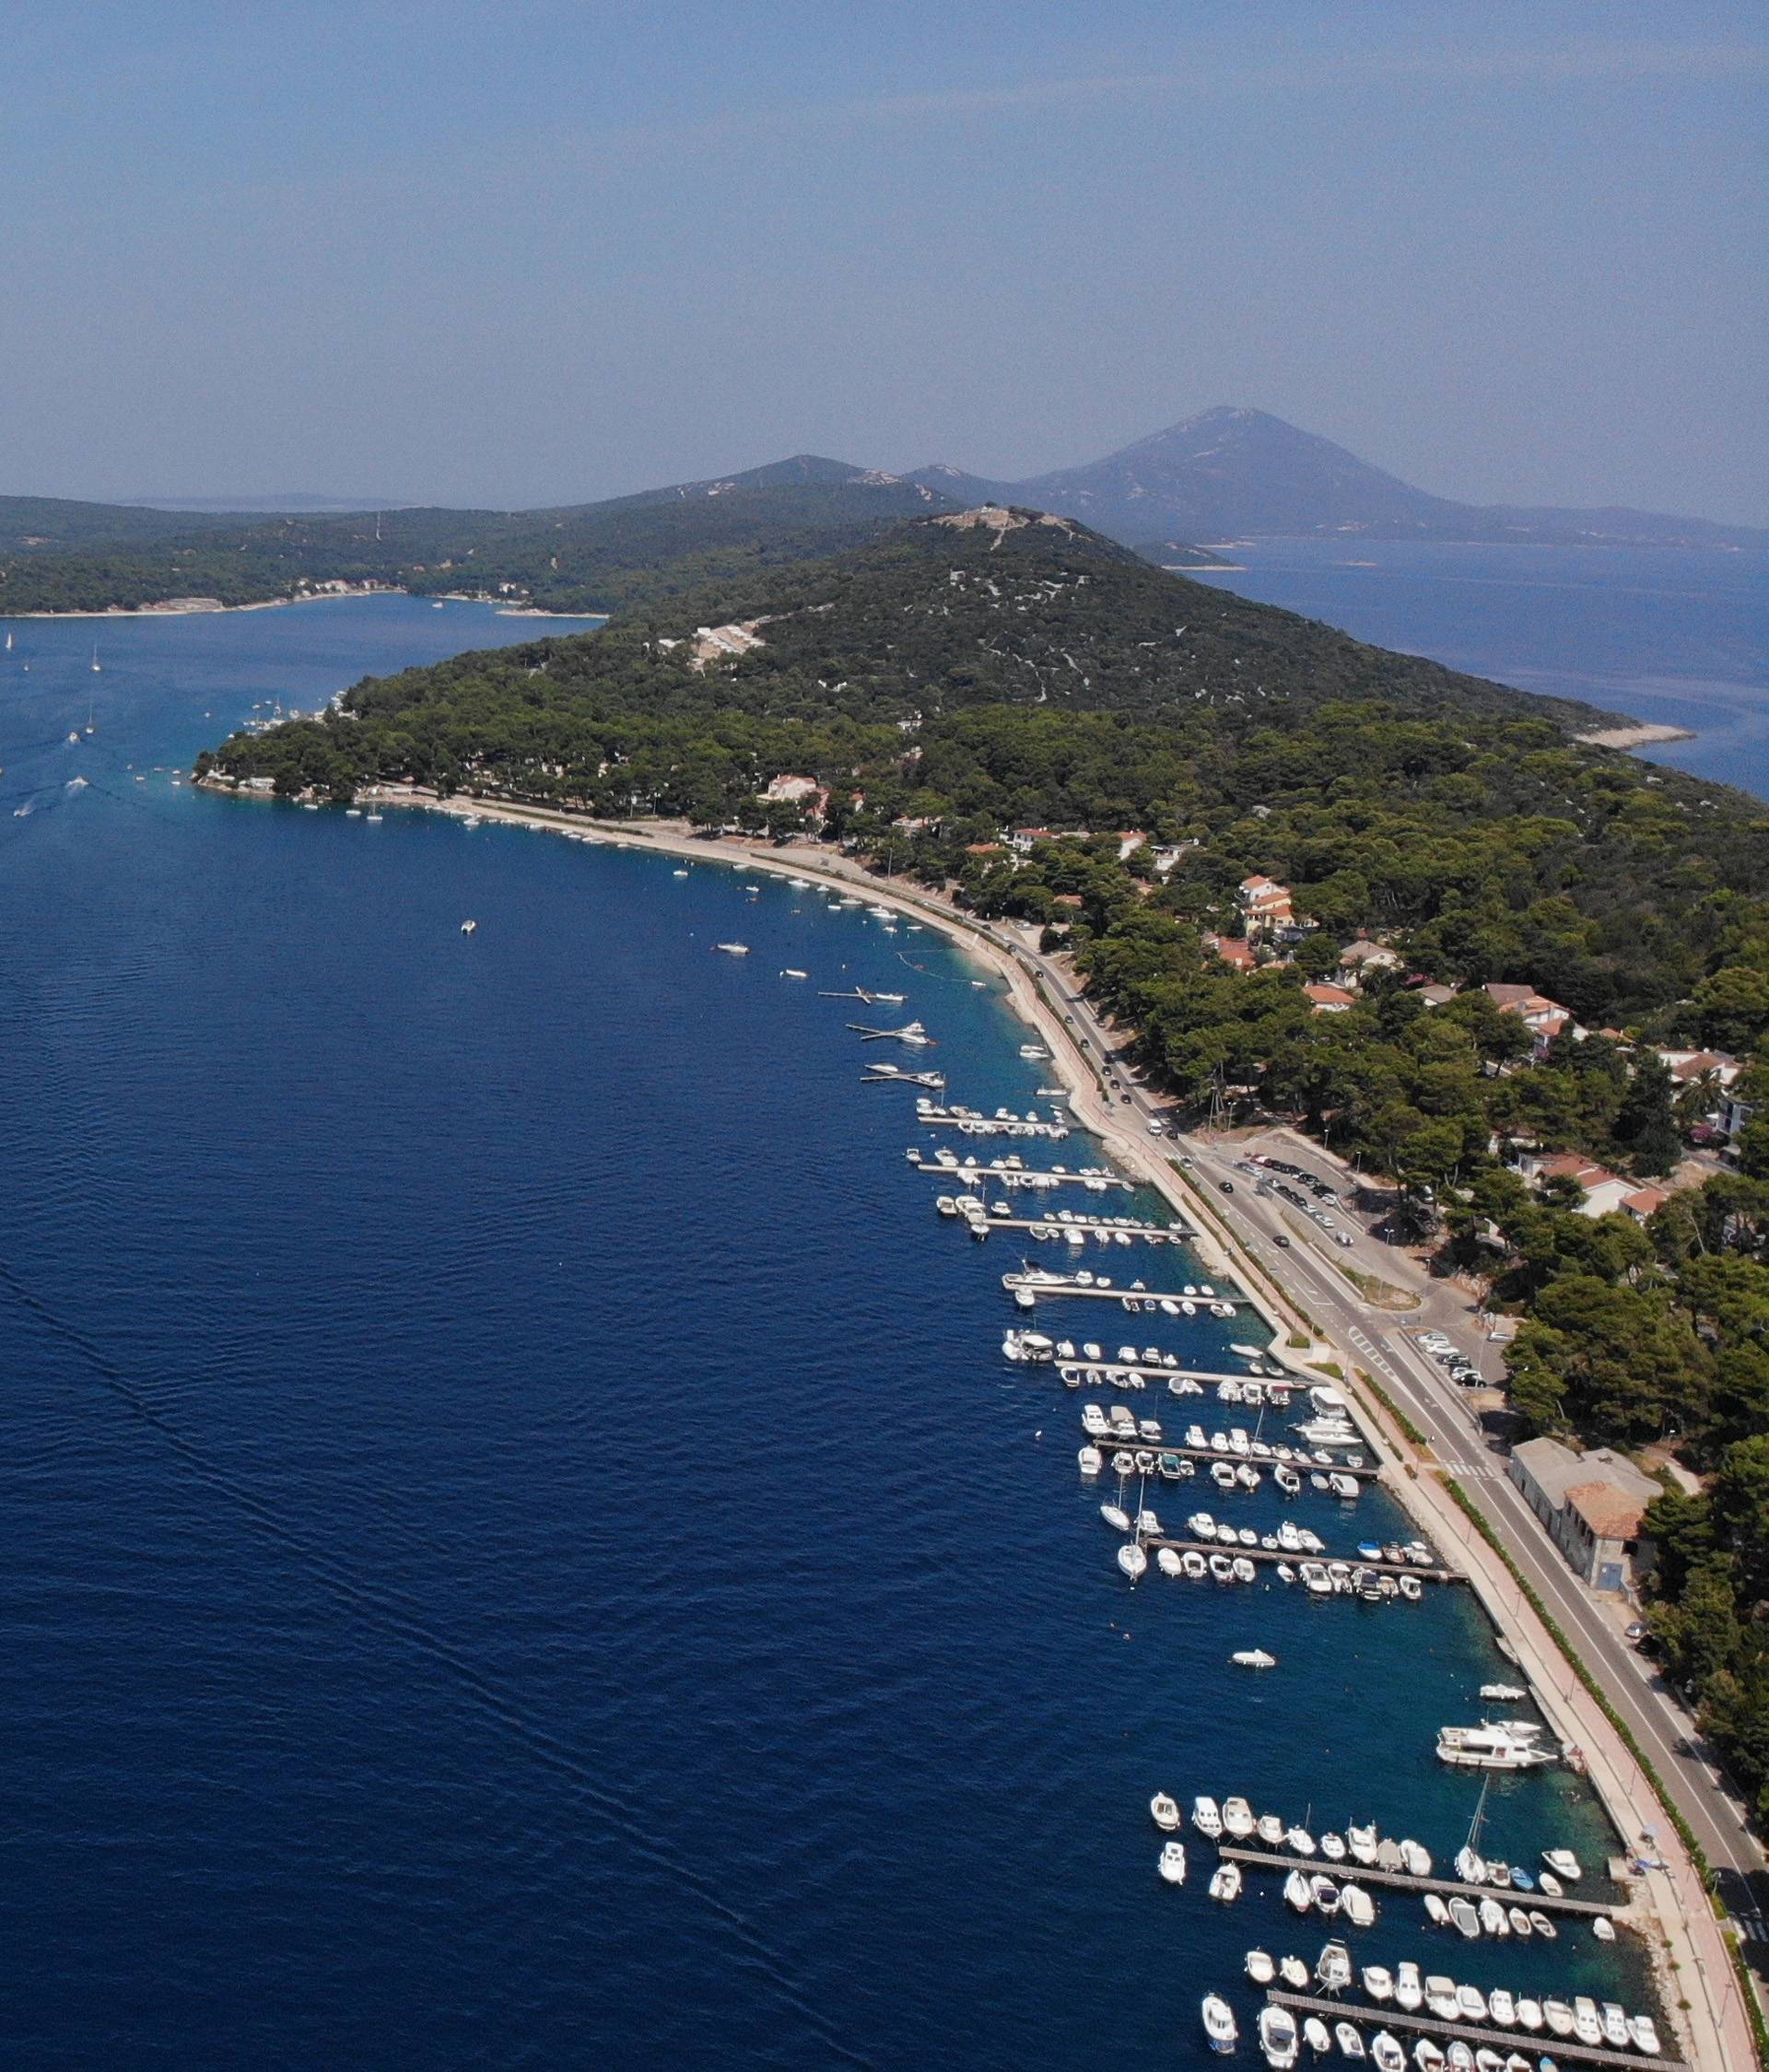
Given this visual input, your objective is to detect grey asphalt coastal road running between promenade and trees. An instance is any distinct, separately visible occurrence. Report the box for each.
[982,907,1769,1939]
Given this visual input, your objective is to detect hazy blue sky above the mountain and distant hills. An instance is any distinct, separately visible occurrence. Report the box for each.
[0,0,1769,524]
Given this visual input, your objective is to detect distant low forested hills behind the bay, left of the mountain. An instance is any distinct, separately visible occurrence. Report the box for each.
[0,454,946,614]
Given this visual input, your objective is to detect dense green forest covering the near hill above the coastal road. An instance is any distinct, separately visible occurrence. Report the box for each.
[199,514,1769,1811]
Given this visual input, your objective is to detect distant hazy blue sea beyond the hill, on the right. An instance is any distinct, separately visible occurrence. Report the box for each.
[1208,539,1769,798]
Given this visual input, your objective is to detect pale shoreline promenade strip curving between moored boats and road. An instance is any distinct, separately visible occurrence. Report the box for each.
[205,779,1754,2072]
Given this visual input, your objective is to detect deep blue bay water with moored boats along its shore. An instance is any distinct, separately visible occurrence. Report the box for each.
[0,599,1645,2072]
